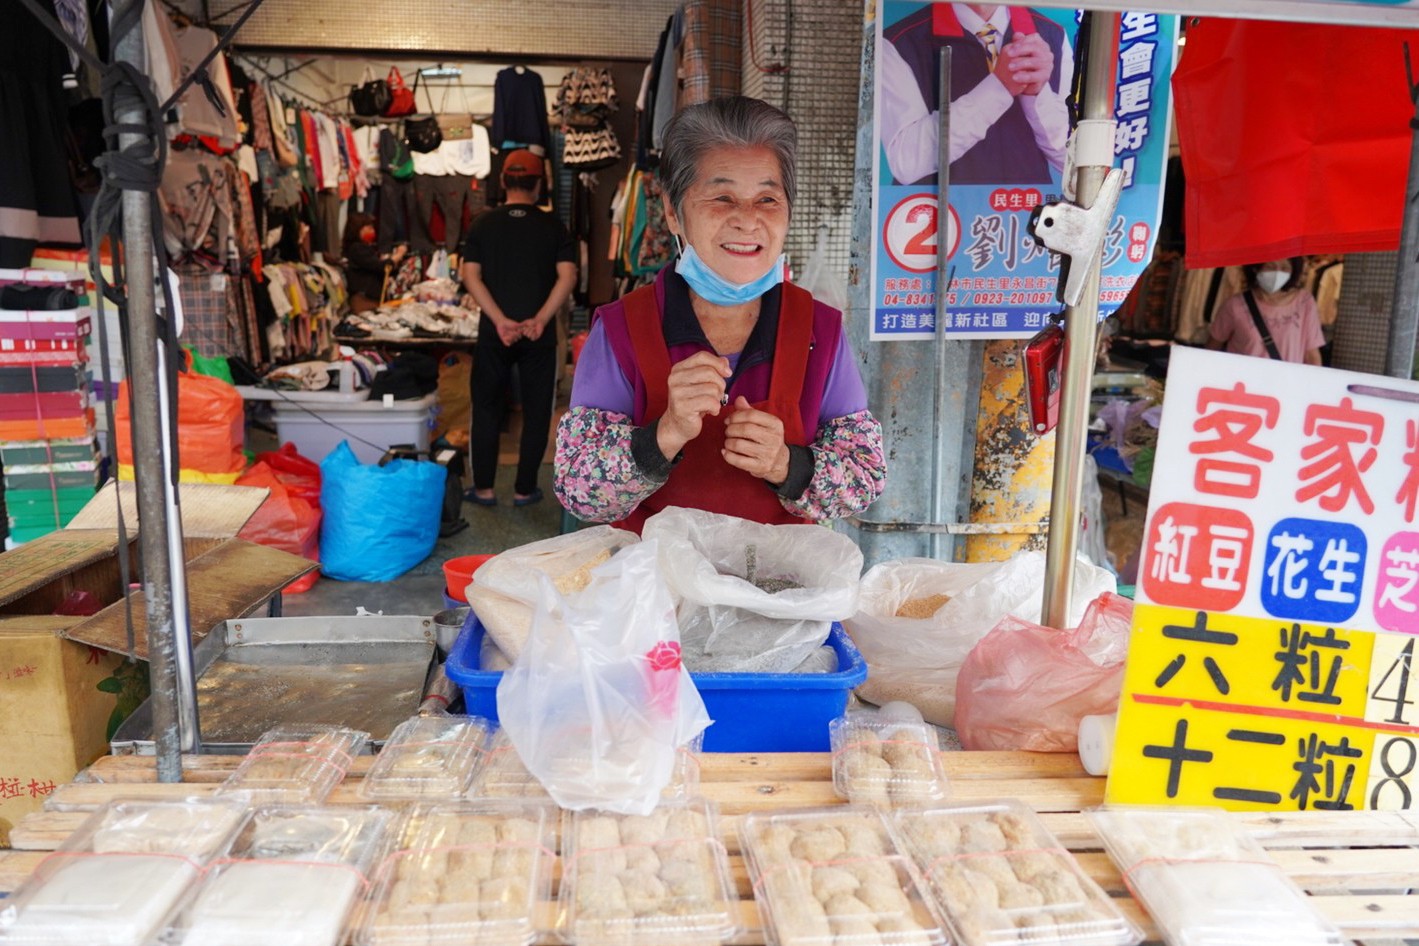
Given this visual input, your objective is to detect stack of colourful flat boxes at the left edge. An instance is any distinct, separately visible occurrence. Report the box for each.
[0,269,102,547]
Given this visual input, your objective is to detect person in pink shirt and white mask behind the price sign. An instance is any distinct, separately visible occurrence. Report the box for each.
[1208,257,1325,365]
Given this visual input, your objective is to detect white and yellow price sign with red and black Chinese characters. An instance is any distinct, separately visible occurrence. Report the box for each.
[1107,347,1419,811]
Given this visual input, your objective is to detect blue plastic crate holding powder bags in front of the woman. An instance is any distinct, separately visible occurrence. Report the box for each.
[444,618,867,752]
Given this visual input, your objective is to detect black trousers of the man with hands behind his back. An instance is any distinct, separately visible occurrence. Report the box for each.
[468,336,556,496]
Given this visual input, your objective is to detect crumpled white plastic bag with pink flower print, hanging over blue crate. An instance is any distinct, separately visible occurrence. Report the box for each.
[496,542,711,814]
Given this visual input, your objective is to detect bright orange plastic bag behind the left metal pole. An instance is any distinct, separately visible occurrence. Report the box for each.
[114,372,247,474]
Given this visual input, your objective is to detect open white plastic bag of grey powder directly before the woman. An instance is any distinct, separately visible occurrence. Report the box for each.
[641,506,863,674]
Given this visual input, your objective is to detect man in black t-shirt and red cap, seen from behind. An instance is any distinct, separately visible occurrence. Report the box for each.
[461,150,576,506]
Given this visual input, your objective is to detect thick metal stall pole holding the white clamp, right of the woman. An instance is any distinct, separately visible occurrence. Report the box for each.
[1043,10,1118,628]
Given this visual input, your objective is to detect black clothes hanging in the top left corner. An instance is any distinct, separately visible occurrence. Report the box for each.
[0,0,79,269]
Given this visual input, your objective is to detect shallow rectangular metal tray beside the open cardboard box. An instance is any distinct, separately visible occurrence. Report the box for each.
[111,616,436,755]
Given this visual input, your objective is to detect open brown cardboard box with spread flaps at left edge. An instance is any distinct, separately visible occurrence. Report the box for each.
[0,482,319,845]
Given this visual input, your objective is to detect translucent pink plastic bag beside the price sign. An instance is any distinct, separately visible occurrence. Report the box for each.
[956,591,1134,752]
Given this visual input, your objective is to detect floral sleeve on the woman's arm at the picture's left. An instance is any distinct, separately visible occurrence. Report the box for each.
[552,407,666,522]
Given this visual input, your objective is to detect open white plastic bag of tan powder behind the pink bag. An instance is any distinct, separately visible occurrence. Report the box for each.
[846,552,1117,726]
